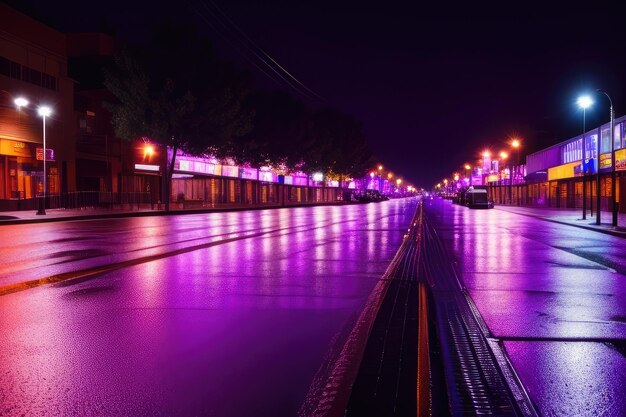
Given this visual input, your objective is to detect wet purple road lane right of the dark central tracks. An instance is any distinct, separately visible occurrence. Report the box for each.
[426,200,626,416]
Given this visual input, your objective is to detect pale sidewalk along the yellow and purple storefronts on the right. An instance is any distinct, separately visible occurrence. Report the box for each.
[495,205,626,237]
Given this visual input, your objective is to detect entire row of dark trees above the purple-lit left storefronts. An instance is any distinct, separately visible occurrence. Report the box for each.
[104,23,372,208]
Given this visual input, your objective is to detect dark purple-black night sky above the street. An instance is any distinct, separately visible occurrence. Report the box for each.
[12,0,626,188]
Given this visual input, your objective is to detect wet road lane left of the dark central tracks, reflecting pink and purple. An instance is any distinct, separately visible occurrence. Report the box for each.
[0,199,416,416]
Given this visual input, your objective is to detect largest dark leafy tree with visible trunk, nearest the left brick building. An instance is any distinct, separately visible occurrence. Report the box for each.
[105,24,253,210]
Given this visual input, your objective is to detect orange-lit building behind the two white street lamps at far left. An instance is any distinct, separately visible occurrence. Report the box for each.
[0,3,76,209]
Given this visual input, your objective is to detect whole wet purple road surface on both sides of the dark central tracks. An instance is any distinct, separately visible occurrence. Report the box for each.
[0,200,626,416]
